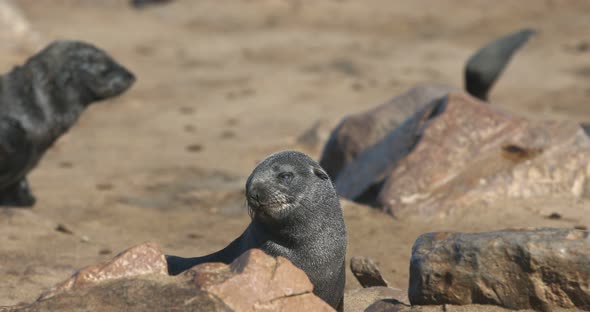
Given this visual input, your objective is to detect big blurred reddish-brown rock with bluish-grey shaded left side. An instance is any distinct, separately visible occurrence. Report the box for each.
[335,92,590,216]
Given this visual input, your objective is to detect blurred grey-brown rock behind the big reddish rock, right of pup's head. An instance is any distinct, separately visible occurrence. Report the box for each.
[320,85,454,179]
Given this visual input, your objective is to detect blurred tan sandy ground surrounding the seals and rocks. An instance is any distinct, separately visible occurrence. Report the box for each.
[0,0,590,305]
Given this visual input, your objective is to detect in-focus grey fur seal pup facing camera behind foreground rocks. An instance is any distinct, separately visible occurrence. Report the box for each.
[166,151,346,309]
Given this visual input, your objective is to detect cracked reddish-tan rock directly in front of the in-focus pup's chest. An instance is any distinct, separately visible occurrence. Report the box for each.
[190,249,333,311]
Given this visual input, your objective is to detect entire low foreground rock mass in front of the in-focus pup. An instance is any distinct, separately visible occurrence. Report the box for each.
[5,243,334,312]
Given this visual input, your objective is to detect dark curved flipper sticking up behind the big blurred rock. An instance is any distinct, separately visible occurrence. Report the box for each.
[465,28,536,101]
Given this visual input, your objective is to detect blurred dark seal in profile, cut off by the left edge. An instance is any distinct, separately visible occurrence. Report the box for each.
[0,41,135,207]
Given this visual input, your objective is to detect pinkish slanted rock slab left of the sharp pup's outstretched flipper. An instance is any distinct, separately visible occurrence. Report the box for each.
[39,243,168,300]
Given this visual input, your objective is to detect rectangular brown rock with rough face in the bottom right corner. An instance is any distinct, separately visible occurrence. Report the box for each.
[409,229,590,311]
